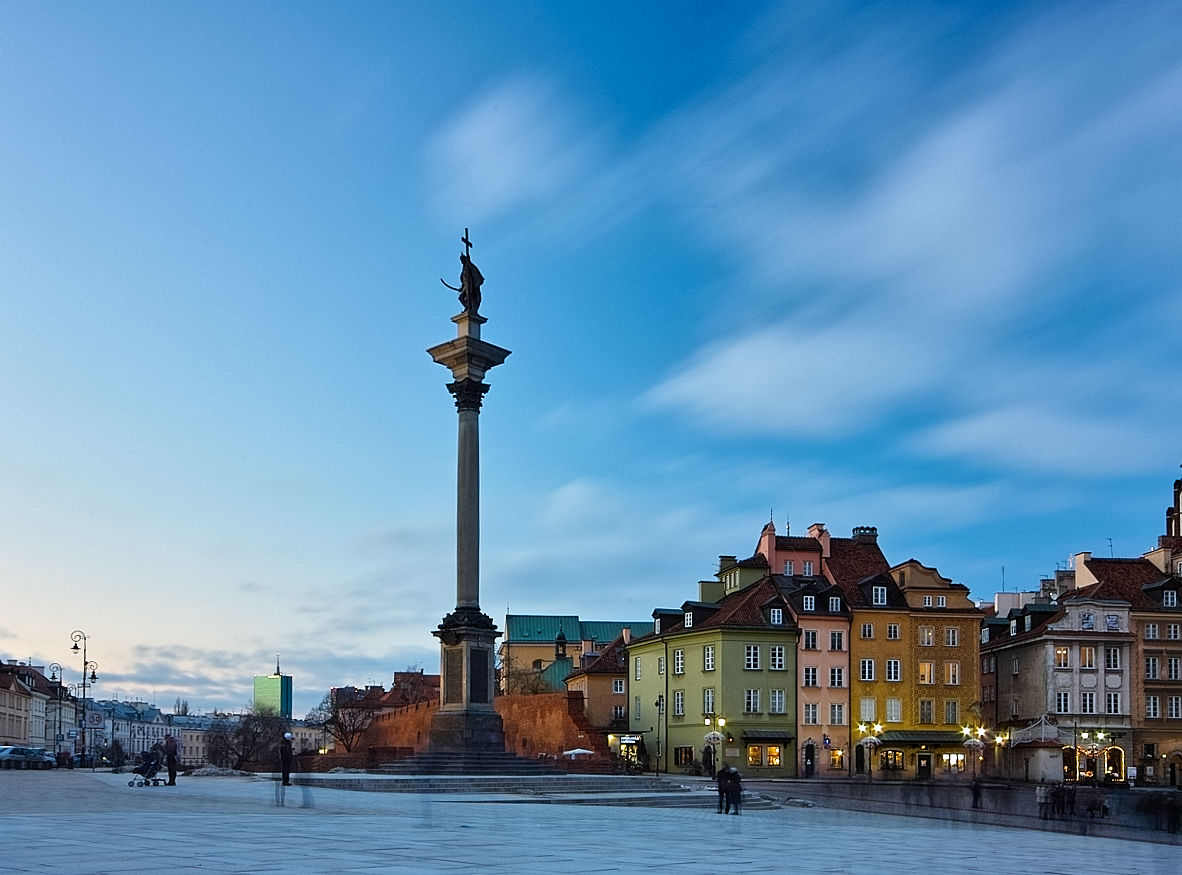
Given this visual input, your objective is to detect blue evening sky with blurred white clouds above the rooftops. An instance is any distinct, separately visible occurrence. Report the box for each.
[0,2,1182,713]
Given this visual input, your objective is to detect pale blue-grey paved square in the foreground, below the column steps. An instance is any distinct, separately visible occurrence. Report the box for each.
[0,771,1180,875]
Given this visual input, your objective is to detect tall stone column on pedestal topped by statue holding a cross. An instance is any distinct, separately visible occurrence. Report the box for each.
[427,228,509,752]
